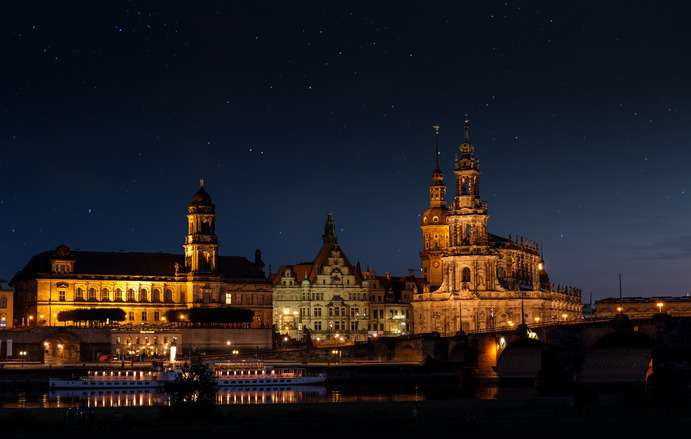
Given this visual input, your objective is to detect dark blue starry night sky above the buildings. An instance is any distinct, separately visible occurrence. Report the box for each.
[0,1,691,301]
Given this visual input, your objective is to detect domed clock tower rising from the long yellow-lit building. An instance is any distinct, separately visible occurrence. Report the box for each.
[183,179,218,274]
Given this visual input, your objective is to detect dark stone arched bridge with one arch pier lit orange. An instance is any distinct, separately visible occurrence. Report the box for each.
[266,314,691,384]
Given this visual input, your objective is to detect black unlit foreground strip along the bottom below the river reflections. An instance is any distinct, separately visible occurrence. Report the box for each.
[0,398,691,439]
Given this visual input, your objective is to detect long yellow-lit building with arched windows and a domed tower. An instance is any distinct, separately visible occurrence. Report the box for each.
[11,180,272,328]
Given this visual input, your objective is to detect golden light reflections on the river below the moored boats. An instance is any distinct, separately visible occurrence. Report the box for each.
[0,385,498,408]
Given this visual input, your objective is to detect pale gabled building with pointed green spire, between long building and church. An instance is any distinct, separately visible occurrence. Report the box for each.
[273,214,422,344]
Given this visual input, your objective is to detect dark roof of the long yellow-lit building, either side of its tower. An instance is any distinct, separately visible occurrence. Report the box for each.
[11,250,264,283]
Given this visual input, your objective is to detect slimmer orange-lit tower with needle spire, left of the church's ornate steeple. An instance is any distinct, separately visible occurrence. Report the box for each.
[420,125,449,289]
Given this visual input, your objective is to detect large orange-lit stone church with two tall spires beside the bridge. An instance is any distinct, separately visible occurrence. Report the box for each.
[412,119,582,336]
